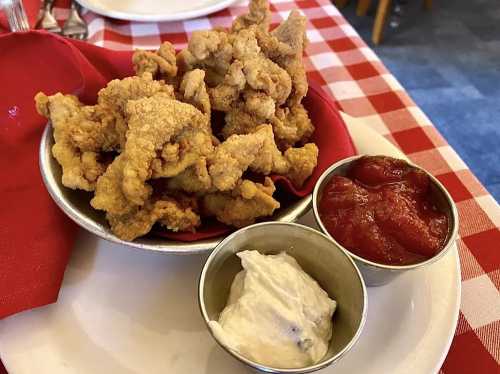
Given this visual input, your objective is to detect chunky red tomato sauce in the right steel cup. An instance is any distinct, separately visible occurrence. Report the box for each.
[318,156,448,265]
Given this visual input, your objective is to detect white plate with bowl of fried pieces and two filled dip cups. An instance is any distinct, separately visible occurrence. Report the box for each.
[0,0,460,374]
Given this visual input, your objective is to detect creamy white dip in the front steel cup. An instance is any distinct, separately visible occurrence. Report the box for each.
[210,251,337,368]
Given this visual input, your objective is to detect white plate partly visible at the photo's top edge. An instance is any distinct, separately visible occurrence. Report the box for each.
[77,0,237,22]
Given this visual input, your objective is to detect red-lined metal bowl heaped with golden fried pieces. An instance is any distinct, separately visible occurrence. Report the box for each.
[35,1,354,253]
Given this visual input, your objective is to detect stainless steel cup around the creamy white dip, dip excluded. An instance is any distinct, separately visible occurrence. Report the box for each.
[198,222,368,373]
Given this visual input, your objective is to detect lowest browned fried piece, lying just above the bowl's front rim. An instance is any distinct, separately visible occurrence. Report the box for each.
[106,198,201,240]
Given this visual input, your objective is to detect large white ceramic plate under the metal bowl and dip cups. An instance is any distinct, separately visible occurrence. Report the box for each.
[0,117,460,374]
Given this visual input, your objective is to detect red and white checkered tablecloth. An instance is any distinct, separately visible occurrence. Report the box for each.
[42,0,500,374]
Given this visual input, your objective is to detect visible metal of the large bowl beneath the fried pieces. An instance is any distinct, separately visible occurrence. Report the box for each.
[39,123,312,254]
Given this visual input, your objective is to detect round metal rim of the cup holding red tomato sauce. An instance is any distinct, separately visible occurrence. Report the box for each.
[312,154,459,270]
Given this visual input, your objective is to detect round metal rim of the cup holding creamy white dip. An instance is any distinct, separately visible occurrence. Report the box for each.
[198,221,368,373]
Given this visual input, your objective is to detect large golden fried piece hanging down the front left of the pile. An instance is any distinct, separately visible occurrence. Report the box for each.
[122,93,207,205]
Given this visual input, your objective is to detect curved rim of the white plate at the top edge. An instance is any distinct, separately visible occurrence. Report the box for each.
[76,0,239,22]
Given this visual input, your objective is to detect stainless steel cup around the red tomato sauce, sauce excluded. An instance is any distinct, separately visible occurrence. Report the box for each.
[313,155,458,286]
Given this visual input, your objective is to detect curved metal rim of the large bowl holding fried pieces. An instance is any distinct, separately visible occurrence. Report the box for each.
[38,121,312,255]
